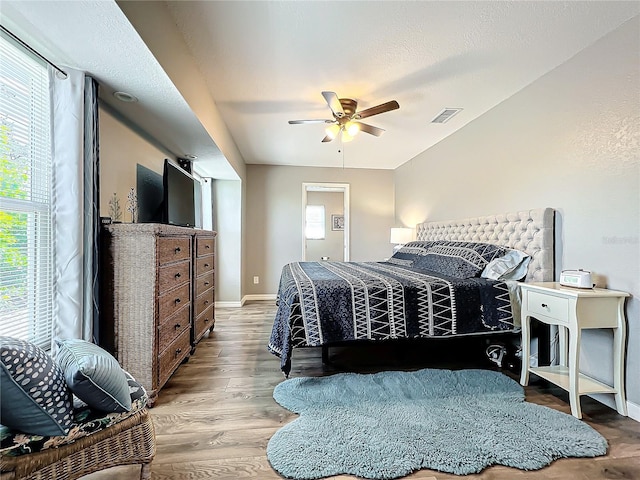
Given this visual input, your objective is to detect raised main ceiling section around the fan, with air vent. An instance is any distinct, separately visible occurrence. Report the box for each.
[168,1,640,168]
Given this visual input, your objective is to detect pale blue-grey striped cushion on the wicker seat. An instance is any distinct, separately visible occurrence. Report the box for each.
[56,339,131,412]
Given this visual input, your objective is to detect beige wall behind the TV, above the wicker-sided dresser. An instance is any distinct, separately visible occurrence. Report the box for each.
[99,108,173,222]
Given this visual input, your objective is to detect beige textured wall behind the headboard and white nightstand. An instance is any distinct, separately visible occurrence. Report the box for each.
[395,18,640,412]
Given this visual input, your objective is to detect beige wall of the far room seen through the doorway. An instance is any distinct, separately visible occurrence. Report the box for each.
[305,192,344,262]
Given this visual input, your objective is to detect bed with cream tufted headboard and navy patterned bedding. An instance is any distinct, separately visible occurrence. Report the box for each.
[268,208,554,376]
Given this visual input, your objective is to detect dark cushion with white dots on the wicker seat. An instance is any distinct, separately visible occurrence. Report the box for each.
[0,337,73,435]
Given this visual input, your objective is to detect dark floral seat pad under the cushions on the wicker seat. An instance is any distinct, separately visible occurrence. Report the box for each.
[0,372,148,457]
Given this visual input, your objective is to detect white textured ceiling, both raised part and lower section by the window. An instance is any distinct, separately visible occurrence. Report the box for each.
[0,0,640,174]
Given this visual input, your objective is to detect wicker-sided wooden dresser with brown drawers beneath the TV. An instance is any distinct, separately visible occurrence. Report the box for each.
[99,223,216,406]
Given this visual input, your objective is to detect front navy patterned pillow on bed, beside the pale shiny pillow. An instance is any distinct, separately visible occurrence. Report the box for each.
[413,241,507,278]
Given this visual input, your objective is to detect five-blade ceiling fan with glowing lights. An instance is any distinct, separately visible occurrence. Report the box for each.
[289,92,400,142]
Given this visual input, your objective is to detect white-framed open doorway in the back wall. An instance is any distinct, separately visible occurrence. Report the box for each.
[302,182,350,262]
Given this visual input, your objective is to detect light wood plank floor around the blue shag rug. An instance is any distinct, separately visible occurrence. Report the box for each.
[86,302,640,480]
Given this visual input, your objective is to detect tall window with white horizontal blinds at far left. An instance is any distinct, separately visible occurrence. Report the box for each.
[0,32,53,350]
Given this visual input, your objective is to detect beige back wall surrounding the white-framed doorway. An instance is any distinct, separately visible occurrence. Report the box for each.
[243,165,394,295]
